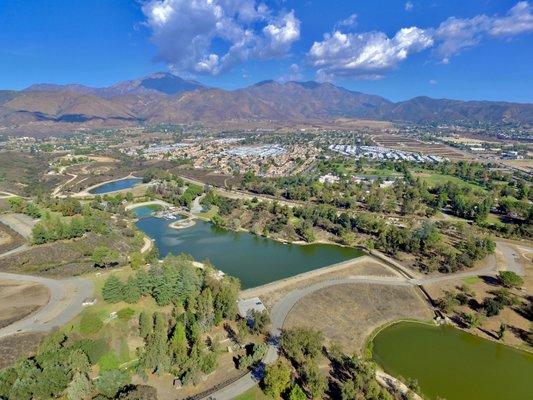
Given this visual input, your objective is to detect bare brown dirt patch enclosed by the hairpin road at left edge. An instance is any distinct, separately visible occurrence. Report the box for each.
[0,280,50,328]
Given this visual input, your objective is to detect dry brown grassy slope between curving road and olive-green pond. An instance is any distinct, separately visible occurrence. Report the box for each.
[284,283,433,353]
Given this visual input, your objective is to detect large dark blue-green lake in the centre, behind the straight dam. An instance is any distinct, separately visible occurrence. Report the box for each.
[135,207,363,288]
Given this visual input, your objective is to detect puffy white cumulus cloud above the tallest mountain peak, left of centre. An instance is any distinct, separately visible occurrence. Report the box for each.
[142,0,300,75]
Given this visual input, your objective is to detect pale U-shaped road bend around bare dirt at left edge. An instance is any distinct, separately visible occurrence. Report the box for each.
[0,272,94,338]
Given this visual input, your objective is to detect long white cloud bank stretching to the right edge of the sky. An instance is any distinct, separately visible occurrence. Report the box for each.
[307,1,533,81]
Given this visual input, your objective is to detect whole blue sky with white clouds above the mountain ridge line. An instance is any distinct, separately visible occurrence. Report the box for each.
[0,0,533,102]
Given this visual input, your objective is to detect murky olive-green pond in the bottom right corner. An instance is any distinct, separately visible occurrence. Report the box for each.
[373,322,533,400]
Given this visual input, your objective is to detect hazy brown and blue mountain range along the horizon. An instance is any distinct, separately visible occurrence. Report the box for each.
[0,73,533,132]
